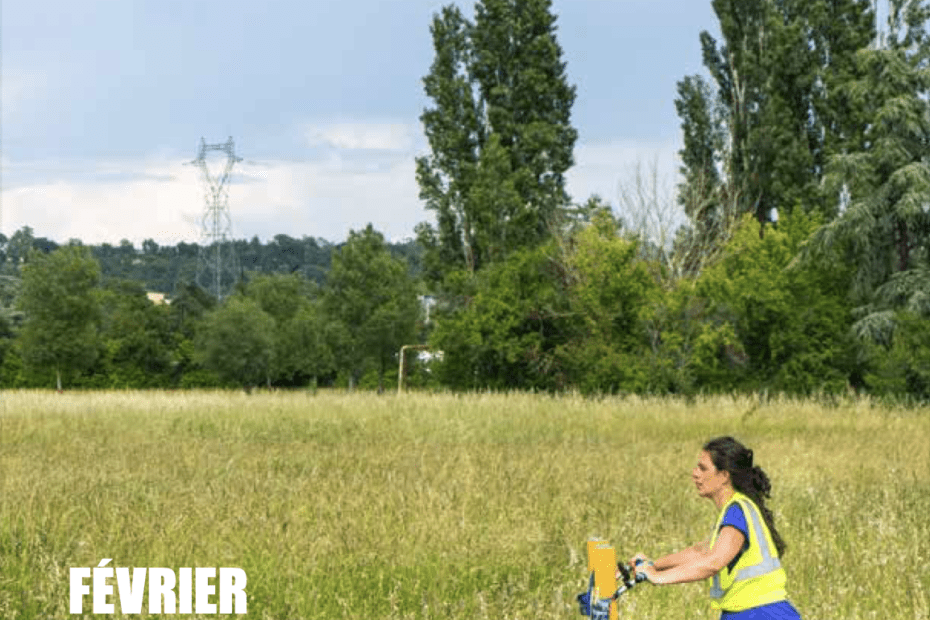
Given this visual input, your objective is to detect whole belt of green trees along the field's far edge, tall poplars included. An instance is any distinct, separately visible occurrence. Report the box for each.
[7,0,930,399]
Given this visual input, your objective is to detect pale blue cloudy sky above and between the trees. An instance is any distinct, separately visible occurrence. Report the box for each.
[0,0,717,247]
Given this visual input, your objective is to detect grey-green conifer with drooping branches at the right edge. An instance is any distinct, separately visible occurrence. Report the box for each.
[810,0,930,346]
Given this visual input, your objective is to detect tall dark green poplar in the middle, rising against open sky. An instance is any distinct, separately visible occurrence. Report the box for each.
[417,0,577,284]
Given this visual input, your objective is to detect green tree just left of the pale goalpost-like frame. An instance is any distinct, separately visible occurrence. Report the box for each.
[324,224,420,389]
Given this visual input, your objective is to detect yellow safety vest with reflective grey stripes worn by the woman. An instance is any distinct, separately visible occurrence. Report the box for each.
[710,491,788,611]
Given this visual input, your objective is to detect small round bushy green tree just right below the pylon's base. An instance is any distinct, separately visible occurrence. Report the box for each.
[195,295,274,390]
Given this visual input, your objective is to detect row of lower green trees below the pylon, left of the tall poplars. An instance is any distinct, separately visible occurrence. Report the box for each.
[0,226,422,390]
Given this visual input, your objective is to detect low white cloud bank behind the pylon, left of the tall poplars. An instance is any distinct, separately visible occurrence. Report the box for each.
[2,147,427,247]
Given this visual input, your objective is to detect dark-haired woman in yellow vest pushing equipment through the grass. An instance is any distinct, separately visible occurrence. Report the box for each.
[633,437,800,620]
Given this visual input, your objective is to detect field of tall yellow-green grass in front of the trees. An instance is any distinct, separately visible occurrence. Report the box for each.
[0,392,930,620]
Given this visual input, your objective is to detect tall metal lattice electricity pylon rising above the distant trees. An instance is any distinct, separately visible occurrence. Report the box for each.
[190,137,242,299]
